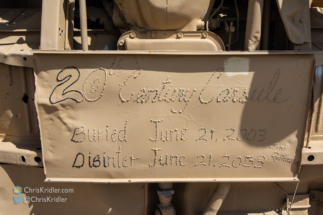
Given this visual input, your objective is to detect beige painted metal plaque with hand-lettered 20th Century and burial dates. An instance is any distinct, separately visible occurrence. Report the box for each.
[35,52,314,182]
